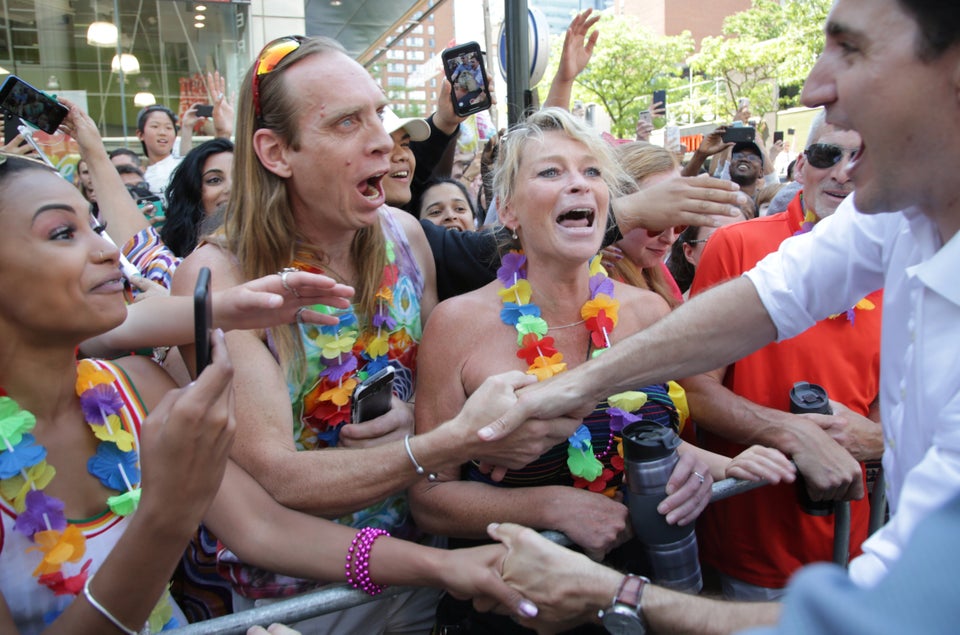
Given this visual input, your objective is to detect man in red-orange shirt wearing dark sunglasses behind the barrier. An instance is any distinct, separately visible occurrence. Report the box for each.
[681,113,883,600]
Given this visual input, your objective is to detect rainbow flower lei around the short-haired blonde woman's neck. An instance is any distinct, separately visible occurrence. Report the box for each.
[497,251,647,492]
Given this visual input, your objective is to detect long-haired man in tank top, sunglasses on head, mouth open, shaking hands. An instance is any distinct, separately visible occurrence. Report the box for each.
[173,36,576,632]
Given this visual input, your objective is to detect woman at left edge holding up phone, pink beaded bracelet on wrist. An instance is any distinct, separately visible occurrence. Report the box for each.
[0,155,529,635]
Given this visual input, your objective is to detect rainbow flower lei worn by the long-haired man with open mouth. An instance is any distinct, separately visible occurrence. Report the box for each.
[291,239,400,446]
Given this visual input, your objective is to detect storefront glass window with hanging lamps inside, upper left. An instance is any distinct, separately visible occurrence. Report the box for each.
[0,0,251,144]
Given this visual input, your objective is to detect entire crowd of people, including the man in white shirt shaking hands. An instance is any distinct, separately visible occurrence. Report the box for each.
[0,0,960,633]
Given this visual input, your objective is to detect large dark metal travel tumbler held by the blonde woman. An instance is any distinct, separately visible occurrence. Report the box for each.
[623,421,703,593]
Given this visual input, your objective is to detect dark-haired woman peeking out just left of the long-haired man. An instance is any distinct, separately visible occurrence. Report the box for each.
[160,138,233,258]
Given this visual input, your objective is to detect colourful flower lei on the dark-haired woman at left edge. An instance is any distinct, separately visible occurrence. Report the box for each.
[0,360,172,630]
